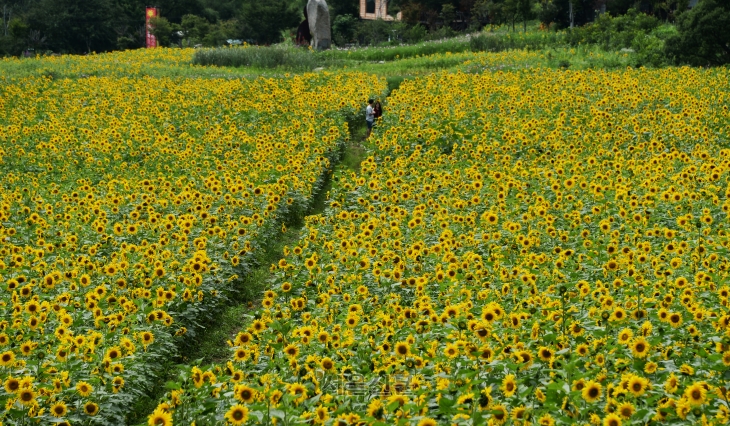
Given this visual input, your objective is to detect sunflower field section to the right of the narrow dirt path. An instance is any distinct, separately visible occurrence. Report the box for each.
[149,68,730,426]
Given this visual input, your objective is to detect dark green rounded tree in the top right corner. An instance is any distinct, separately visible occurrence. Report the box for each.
[666,0,730,65]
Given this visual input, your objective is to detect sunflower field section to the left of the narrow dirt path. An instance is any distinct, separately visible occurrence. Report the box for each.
[0,59,384,425]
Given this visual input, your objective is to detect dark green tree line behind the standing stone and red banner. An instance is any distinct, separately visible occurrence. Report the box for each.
[0,0,730,64]
